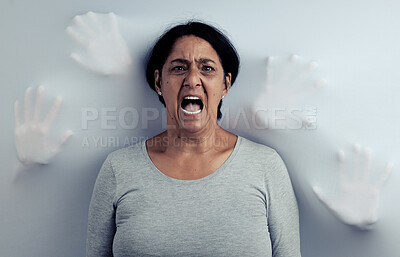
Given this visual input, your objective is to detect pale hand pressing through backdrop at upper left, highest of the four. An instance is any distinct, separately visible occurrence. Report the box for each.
[66,12,132,75]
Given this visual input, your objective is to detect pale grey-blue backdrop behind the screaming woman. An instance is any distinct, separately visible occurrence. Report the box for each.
[0,0,400,257]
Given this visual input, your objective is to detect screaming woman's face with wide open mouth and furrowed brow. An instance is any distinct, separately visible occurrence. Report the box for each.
[154,36,231,133]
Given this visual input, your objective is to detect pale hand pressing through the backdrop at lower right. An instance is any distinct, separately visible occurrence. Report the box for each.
[313,144,393,229]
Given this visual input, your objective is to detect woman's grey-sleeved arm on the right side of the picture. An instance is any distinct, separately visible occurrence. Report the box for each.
[266,153,301,257]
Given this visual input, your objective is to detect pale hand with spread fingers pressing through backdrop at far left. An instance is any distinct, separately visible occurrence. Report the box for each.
[14,86,72,166]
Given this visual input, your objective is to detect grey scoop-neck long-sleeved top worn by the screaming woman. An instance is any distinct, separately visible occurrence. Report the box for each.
[86,137,301,257]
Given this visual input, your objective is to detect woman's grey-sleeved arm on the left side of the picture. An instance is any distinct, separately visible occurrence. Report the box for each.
[86,159,116,257]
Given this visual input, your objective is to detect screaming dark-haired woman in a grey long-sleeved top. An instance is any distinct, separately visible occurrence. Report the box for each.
[87,22,300,257]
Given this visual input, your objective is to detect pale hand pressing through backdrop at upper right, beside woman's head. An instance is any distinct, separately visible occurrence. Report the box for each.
[252,54,326,129]
